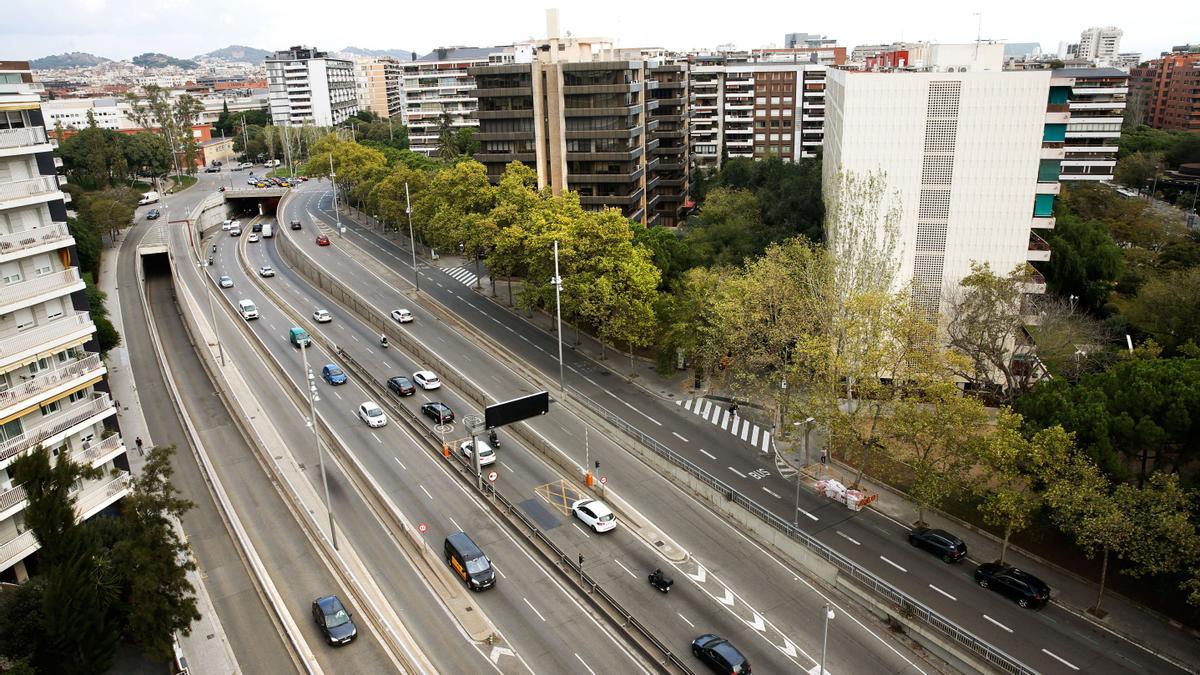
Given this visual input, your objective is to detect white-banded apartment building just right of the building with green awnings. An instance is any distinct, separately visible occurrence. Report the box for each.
[1048,67,1129,180]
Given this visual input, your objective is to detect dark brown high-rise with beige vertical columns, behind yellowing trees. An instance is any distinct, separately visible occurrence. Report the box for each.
[468,31,686,225]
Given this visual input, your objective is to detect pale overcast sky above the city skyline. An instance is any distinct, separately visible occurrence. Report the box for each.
[0,0,1200,60]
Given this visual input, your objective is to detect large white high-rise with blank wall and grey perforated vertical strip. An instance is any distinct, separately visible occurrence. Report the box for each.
[822,48,1070,316]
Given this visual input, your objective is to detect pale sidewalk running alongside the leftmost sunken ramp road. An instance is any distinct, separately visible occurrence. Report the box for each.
[96,226,241,674]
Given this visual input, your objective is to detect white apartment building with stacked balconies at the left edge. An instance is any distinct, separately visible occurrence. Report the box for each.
[0,61,130,583]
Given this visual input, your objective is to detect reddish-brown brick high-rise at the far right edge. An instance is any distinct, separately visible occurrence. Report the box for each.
[1129,44,1200,131]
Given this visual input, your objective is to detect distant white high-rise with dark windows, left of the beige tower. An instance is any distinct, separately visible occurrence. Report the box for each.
[266,47,359,126]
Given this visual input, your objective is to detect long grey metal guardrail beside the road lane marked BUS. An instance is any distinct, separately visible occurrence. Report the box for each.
[568,387,1037,675]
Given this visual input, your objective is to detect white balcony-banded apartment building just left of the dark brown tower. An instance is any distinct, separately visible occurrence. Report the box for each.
[401,47,501,156]
